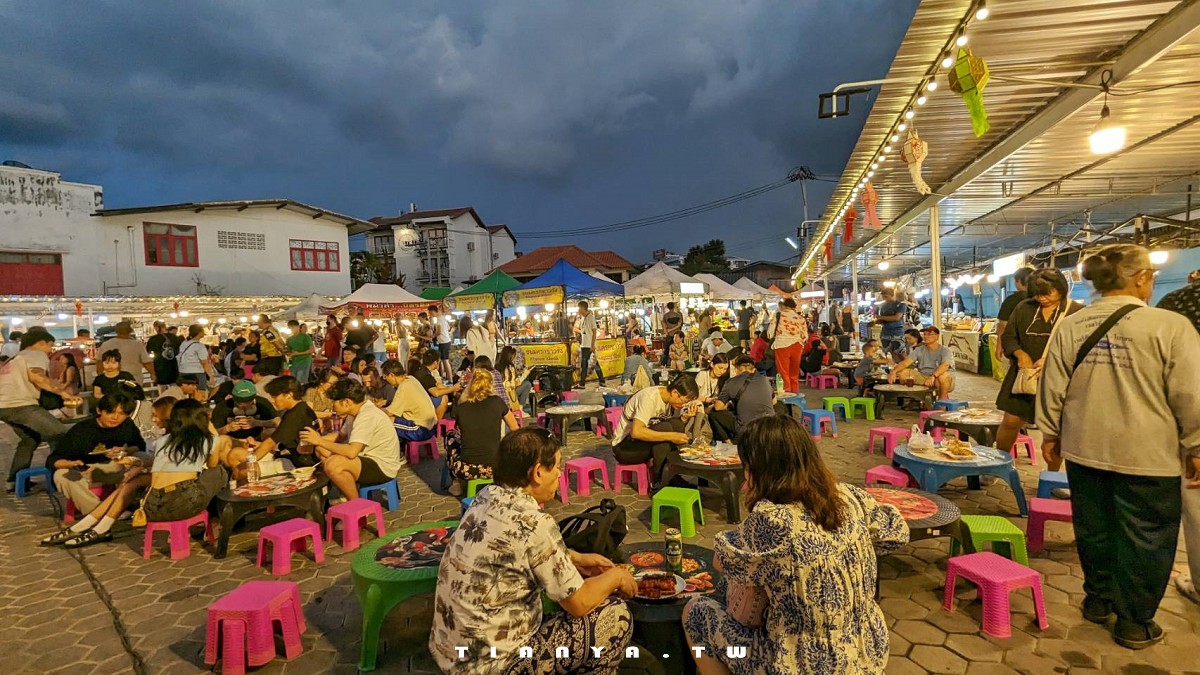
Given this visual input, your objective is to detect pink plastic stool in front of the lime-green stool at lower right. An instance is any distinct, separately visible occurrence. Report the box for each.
[942,551,1050,638]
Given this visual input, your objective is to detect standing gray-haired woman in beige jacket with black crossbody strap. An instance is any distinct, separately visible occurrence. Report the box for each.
[1036,244,1200,649]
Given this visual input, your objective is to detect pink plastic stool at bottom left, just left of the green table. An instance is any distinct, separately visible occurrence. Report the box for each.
[204,581,307,674]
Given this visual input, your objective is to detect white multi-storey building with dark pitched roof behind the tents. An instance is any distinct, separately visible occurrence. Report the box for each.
[366,207,517,293]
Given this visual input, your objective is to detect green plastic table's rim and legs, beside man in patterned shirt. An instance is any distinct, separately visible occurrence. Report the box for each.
[350,520,458,671]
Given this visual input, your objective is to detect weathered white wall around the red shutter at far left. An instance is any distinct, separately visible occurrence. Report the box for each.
[0,166,103,295]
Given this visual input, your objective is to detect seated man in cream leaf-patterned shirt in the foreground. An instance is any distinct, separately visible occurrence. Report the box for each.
[430,428,637,675]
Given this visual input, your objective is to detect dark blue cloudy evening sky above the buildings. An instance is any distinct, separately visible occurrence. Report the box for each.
[0,0,917,262]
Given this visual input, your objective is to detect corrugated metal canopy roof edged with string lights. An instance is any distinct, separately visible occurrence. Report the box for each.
[802,0,1200,279]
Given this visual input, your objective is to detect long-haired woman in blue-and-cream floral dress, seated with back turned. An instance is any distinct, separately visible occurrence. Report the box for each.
[683,417,908,675]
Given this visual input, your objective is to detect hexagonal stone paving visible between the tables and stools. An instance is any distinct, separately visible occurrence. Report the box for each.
[0,375,1200,675]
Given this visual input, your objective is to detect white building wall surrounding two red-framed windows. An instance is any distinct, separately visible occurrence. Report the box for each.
[92,205,350,295]
